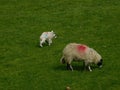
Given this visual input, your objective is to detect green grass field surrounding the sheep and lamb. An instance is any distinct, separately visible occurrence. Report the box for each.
[0,0,120,90]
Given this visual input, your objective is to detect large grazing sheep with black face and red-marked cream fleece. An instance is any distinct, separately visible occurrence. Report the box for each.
[60,43,103,72]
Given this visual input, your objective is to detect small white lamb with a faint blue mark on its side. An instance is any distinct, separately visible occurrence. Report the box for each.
[40,31,57,47]
